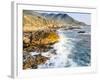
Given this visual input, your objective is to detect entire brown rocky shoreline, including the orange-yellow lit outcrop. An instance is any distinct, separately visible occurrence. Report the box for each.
[23,30,59,69]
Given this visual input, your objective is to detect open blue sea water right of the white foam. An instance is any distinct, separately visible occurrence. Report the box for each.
[64,29,91,66]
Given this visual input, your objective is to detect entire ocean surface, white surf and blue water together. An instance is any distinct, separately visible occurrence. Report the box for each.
[38,26,91,68]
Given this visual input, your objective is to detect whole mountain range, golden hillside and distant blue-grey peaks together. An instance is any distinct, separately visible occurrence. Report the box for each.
[23,10,86,32]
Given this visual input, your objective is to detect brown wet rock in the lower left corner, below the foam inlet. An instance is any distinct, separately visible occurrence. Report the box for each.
[23,54,49,69]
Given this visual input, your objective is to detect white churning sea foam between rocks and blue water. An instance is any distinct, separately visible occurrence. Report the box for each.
[38,30,77,68]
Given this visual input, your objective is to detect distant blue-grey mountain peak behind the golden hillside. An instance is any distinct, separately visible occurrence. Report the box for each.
[42,13,86,26]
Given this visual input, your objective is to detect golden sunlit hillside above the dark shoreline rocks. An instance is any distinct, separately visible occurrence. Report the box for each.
[23,12,58,32]
